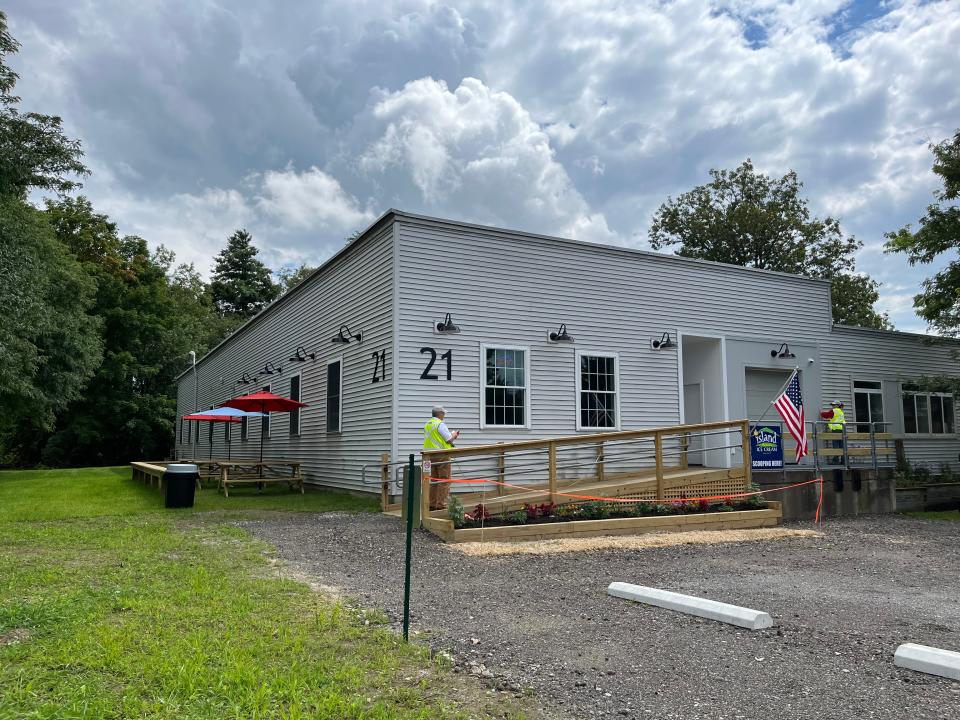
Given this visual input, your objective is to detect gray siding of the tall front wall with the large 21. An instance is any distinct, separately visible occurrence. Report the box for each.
[396,215,830,462]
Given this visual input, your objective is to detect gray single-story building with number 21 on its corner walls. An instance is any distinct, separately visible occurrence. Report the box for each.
[176,205,960,491]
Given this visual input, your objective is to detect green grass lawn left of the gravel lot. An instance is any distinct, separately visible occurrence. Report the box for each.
[0,468,531,720]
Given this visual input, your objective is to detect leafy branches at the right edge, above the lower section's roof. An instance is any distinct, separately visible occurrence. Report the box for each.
[886,130,960,337]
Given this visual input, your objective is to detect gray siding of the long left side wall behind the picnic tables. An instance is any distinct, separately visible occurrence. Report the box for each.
[177,223,394,490]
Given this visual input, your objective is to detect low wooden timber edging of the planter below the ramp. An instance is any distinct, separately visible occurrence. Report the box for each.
[423,502,783,542]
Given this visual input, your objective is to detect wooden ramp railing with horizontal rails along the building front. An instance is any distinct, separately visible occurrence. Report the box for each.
[421,420,751,529]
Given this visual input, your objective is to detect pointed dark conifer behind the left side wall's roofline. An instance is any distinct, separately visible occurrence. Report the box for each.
[210,230,280,318]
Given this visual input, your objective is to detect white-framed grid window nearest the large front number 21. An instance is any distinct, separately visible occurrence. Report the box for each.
[482,345,529,427]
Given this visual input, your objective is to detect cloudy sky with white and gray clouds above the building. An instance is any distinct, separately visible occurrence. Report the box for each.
[6,0,960,330]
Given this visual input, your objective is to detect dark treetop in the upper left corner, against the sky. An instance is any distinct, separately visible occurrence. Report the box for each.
[0,11,88,198]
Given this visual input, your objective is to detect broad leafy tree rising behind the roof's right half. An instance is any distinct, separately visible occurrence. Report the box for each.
[649,159,890,328]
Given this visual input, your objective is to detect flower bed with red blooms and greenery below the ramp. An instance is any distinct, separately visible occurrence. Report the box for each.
[447,495,766,530]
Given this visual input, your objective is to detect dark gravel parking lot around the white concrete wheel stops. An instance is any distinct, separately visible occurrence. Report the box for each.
[244,514,960,720]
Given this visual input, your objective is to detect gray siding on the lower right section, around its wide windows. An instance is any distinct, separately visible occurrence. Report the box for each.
[823,325,960,471]
